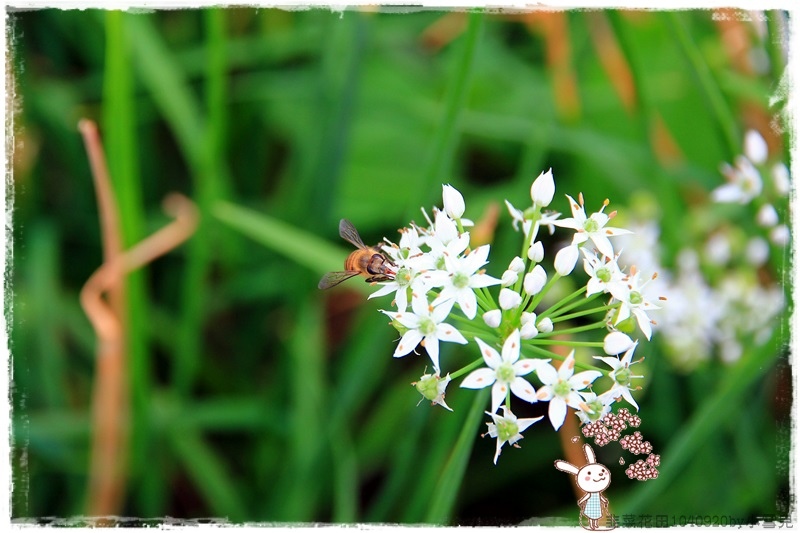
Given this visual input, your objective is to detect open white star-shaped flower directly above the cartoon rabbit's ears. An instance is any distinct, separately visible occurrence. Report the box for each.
[536,350,603,431]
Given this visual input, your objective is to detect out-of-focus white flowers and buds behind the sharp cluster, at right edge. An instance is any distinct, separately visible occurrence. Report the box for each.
[620,131,789,371]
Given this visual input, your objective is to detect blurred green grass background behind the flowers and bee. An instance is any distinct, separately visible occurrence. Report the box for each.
[7,8,793,525]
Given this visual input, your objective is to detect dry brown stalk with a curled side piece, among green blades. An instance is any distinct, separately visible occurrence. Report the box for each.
[79,120,198,516]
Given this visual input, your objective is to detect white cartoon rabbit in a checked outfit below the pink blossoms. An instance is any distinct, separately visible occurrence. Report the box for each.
[555,444,614,531]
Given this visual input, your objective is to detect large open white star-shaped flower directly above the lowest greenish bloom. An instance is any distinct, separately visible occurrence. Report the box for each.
[461,329,541,413]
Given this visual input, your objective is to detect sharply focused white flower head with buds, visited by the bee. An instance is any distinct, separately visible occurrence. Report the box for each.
[370,171,658,462]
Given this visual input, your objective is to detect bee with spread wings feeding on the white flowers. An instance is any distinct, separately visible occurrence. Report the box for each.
[317,218,397,289]
